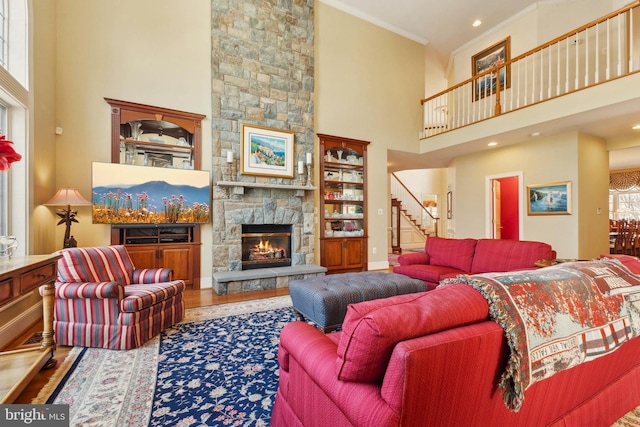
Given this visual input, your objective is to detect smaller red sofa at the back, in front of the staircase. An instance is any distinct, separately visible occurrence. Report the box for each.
[393,237,556,289]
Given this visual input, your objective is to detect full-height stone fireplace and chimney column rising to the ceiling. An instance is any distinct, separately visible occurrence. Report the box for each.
[211,0,326,295]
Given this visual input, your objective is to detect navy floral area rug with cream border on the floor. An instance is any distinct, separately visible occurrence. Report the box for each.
[33,296,294,427]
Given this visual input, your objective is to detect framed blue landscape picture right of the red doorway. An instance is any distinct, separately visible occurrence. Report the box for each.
[527,181,571,215]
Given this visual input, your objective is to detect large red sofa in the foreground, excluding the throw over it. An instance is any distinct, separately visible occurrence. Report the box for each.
[271,270,640,427]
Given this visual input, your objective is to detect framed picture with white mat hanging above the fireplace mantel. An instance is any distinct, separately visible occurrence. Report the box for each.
[240,124,294,178]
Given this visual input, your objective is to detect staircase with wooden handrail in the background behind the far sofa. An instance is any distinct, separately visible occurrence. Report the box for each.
[391,173,440,252]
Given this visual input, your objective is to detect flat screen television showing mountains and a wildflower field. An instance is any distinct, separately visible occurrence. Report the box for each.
[91,162,211,225]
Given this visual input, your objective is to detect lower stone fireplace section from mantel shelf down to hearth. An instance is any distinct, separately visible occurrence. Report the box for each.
[212,186,326,295]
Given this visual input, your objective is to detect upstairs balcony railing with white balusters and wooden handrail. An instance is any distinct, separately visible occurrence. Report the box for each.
[421,2,640,138]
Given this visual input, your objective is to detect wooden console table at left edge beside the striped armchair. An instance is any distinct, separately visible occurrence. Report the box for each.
[0,255,60,404]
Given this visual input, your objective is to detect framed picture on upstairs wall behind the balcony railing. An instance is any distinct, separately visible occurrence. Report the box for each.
[471,37,511,101]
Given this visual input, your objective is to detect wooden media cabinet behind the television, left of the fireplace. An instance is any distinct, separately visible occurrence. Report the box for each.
[105,98,205,289]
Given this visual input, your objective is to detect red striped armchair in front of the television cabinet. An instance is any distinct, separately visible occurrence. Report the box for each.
[47,245,185,350]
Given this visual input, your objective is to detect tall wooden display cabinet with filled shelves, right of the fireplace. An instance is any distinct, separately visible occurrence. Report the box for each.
[318,134,369,273]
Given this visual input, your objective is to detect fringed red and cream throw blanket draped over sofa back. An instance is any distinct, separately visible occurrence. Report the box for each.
[443,260,640,411]
